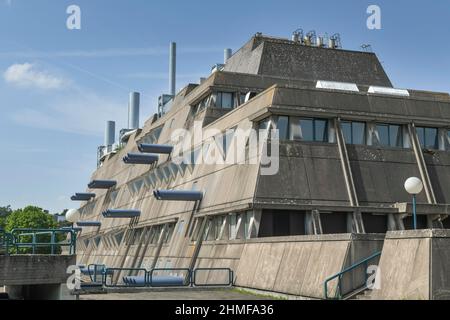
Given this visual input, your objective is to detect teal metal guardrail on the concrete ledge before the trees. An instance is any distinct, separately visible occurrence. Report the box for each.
[0,229,77,255]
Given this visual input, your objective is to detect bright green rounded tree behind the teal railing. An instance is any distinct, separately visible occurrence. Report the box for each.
[5,206,62,254]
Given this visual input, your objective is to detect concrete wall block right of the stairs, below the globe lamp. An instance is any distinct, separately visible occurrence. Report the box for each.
[371,230,450,300]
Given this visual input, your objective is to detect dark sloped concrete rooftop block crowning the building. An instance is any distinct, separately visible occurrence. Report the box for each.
[224,36,392,87]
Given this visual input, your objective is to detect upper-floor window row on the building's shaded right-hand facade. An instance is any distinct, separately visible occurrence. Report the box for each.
[264,116,450,150]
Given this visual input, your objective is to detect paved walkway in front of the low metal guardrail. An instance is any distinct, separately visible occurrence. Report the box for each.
[80,289,272,300]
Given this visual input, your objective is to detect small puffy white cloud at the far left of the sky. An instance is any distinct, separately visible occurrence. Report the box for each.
[3,63,68,90]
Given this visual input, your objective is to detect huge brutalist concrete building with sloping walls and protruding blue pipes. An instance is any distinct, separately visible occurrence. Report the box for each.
[69,34,450,299]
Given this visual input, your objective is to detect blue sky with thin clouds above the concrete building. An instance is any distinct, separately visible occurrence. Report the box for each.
[0,0,450,212]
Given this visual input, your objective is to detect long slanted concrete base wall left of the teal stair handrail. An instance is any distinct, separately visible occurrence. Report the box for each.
[193,234,383,299]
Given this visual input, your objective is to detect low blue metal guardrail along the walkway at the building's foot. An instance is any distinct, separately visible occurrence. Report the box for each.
[96,265,234,288]
